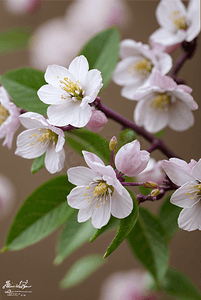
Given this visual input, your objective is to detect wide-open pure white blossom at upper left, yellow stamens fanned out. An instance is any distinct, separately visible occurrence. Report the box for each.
[38,55,102,127]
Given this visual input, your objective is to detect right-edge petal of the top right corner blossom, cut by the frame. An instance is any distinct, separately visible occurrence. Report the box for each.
[186,0,200,42]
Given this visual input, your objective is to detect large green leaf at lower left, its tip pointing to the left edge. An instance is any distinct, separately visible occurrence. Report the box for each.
[6,175,74,250]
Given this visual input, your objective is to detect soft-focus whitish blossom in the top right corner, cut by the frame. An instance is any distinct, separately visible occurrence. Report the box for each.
[150,0,200,46]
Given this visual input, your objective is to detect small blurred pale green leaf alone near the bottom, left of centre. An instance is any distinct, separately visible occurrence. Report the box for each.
[60,254,106,289]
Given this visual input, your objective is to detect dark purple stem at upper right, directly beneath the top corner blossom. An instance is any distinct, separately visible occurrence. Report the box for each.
[168,38,197,84]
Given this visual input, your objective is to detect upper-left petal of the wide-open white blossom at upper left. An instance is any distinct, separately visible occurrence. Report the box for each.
[45,65,76,89]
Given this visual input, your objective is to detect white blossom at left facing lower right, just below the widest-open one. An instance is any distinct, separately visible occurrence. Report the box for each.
[15,112,65,174]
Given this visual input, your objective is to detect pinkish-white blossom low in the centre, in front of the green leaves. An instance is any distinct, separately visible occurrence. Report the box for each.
[67,151,133,228]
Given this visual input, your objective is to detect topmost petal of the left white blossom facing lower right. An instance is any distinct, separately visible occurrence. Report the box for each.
[19,112,48,129]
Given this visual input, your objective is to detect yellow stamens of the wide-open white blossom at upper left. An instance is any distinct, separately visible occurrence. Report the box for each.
[60,77,84,100]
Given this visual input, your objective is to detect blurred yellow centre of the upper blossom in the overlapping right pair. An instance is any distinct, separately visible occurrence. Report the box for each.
[128,58,154,77]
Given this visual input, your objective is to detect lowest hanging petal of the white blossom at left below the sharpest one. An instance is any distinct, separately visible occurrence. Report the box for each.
[45,143,65,174]
